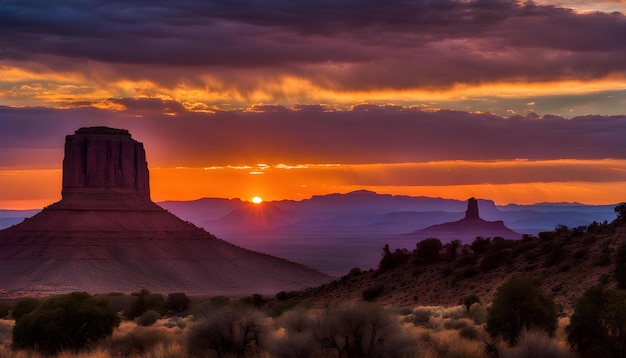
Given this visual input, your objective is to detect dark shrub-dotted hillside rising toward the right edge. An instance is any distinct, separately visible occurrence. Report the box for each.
[292,213,626,311]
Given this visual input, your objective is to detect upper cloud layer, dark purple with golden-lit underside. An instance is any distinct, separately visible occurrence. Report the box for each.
[0,0,626,115]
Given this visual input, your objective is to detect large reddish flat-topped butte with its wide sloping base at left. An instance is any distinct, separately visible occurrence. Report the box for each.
[0,127,330,297]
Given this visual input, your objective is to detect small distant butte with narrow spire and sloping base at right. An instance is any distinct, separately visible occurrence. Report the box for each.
[402,198,522,243]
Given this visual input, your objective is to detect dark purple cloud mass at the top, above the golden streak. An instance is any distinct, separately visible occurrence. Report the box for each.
[0,0,626,89]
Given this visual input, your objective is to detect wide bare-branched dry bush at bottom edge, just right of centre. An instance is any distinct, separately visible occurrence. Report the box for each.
[316,302,413,357]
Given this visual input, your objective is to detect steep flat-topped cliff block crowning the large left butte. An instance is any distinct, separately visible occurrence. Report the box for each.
[62,127,150,200]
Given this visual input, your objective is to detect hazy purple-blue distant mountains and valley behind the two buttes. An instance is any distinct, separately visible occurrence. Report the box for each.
[0,190,615,276]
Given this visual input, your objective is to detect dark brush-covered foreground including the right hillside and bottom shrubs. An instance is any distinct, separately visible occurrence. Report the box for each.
[0,206,626,358]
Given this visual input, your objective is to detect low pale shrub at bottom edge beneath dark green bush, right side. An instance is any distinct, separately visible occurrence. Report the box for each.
[500,330,572,358]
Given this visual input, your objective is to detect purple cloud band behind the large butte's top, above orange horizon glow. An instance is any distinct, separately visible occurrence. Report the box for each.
[0,105,626,167]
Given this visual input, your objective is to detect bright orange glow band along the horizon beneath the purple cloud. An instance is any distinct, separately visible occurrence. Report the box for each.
[0,159,626,209]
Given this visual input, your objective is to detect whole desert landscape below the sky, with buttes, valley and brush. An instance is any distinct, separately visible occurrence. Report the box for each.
[0,127,626,357]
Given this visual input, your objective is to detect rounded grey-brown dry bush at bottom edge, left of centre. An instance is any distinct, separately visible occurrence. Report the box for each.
[185,306,270,357]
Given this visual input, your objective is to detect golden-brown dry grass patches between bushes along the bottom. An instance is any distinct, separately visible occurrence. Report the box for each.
[0,304,573,358]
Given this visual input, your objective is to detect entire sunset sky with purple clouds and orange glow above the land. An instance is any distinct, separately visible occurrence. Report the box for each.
[0,0,626,209]
